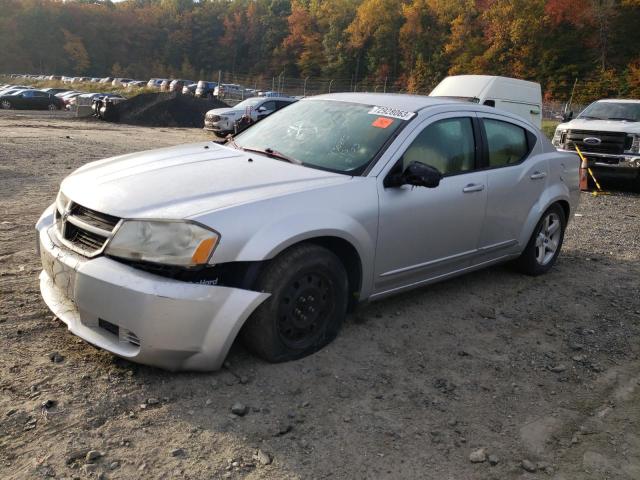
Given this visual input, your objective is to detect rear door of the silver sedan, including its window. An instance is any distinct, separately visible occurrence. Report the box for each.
[478,113,549,261]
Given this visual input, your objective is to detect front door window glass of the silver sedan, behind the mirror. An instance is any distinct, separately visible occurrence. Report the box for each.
[402,117,475,175]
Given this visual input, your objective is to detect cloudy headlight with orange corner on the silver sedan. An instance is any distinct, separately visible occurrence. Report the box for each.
[105,220,220,267]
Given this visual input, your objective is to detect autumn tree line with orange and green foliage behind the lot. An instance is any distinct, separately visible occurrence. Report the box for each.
[0,0,640,102]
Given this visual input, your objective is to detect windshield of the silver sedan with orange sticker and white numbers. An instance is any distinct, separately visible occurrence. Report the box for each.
[235,99,414,175]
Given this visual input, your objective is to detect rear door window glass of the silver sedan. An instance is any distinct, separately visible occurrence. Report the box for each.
[483,118,529,167]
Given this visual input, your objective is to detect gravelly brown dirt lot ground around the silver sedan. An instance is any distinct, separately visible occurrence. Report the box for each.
[0,111,640,480]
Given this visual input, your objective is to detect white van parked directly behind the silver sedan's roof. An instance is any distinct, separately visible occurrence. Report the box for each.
[429,75,542,128]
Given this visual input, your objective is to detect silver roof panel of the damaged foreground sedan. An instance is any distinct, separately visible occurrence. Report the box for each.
[305,92,461,112]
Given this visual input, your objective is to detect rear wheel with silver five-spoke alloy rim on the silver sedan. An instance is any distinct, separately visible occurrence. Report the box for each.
[515,203,567,276]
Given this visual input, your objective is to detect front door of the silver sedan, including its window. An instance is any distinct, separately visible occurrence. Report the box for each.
[374,112,487,296]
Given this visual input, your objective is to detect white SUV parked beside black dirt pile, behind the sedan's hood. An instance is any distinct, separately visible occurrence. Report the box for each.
[204,97,296,136]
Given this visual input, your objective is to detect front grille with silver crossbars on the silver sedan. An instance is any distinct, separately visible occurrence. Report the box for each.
[55,202,120,257]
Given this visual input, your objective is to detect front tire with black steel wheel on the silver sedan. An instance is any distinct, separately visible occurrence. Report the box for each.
[242,244,349,363]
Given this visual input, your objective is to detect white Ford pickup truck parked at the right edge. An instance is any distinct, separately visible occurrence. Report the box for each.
[552,99,640,188]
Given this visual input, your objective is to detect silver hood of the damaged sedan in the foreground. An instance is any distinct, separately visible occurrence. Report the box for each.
[61,142,352,219]
